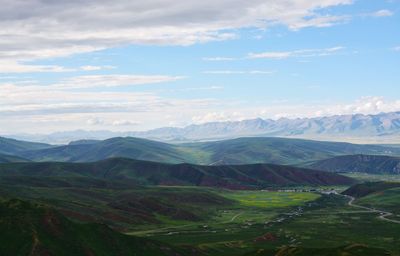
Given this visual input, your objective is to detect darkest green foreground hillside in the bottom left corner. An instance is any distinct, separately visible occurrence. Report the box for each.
[0,200,181,256]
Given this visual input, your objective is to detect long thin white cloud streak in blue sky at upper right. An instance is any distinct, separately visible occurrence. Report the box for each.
[248,46,344,60]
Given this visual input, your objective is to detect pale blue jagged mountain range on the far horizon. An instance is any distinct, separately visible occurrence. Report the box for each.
[6,112,400,144]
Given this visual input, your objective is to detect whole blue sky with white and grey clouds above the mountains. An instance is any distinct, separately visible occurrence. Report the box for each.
[0,0,400,135]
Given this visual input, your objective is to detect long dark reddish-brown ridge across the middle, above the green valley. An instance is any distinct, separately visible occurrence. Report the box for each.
[0,158,353,189]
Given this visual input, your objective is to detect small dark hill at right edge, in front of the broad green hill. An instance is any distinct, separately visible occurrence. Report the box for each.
[308,155,400,174]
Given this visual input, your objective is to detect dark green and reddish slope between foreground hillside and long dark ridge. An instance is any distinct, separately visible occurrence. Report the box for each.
[0,183,233,230]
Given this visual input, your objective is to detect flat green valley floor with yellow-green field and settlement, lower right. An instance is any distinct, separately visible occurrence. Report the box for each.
[145,192,400,256]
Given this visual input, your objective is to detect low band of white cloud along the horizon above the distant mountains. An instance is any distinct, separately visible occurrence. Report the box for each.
[0,83,400,134]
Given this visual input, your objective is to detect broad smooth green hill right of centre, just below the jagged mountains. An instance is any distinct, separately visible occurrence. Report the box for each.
[191,138,400,164]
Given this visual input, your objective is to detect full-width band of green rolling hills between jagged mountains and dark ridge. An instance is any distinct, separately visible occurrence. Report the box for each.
[0,137,400,165]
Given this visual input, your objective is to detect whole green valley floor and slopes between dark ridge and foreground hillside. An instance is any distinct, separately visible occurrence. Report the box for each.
[0,174,400,256]
